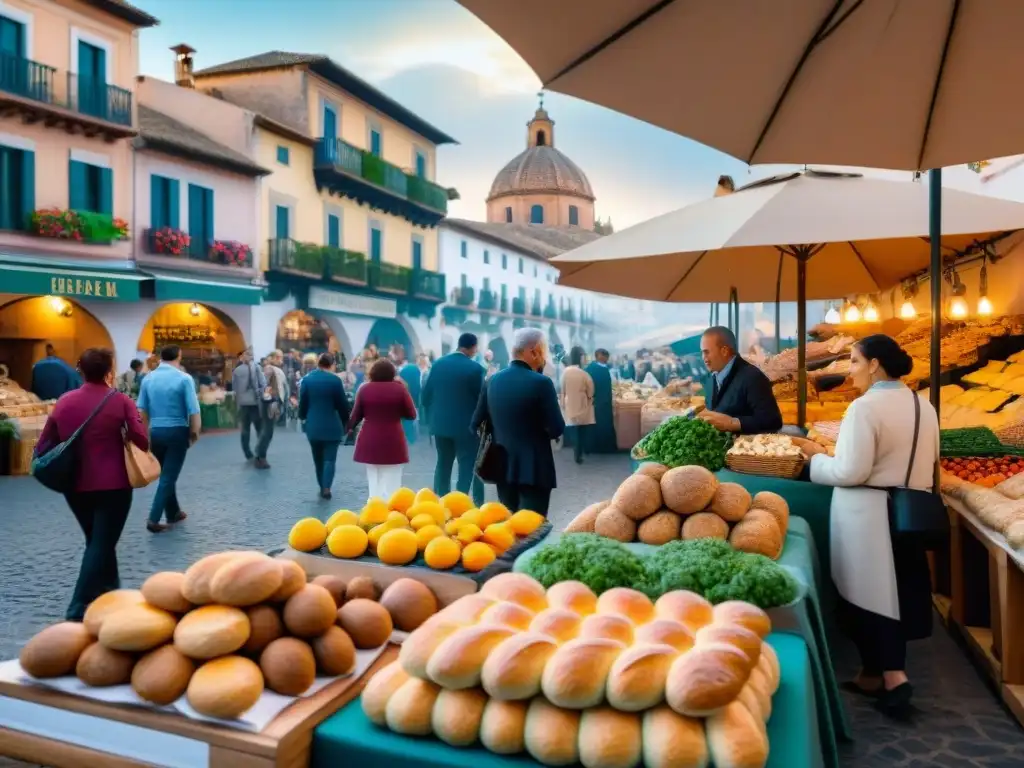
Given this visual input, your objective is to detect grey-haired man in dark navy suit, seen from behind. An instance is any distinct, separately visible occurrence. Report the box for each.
[473,328,565,516]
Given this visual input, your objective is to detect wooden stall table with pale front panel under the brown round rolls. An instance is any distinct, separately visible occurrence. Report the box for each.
[0,648,395,768]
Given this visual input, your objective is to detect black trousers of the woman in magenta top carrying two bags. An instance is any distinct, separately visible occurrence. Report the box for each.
[65,488,132,622]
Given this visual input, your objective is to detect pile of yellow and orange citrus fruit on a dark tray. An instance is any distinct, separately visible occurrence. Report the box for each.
[288,488,544,571]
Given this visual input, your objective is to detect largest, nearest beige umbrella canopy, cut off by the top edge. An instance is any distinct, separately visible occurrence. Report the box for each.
[459,0,1024,170]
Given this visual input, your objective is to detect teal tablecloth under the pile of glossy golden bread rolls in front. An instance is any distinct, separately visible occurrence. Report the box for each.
[309,634,825,768]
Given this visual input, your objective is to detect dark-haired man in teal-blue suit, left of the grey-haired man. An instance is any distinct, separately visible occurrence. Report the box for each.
[420,334,485,506]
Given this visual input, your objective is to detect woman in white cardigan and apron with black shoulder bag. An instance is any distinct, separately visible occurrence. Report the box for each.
[810,334,939,716]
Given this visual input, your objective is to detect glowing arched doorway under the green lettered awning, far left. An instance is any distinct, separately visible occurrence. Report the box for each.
[0,296,113,389]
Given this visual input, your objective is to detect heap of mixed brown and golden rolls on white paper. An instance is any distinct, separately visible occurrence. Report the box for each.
[19,552,437,720]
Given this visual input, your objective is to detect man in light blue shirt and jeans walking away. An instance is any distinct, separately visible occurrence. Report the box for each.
[137,345,200,534]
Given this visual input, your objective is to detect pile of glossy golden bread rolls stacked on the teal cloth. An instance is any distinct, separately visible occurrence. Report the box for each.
[362,573,779,768]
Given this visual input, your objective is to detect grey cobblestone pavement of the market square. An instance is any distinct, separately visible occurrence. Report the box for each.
[0,430,1024,768]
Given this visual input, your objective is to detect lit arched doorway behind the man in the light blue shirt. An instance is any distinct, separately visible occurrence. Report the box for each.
[138,301,248,385]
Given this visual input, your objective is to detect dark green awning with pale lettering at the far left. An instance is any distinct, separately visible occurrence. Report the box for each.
[0,261,152,301]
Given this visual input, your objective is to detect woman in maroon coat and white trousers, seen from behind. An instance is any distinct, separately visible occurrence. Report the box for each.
[348,358,416,501]
